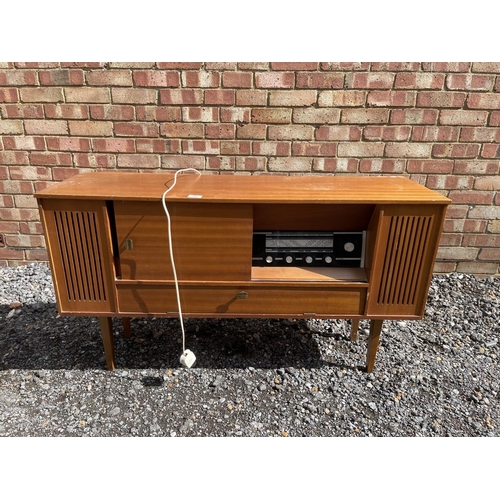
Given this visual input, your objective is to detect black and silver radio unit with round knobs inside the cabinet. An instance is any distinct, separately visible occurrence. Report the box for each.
[252,231,365,267]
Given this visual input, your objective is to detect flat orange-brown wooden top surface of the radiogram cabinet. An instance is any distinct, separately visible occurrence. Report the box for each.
[35,172,450,204]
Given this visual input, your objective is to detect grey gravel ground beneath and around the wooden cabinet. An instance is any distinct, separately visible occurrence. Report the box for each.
[0,264,500,437]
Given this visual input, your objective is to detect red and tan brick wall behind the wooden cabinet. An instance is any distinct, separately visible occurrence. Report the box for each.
[0,62,500,275]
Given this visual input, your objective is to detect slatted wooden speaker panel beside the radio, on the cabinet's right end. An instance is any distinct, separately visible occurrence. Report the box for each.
[366,205,445,318]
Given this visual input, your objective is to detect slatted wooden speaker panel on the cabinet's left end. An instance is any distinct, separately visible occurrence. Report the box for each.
[39,199,116,315]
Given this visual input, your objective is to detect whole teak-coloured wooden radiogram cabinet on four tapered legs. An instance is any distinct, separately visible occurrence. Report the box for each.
[35,172,450,371]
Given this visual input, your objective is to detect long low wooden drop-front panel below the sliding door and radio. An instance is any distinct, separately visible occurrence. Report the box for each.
[118,283,366,317]
